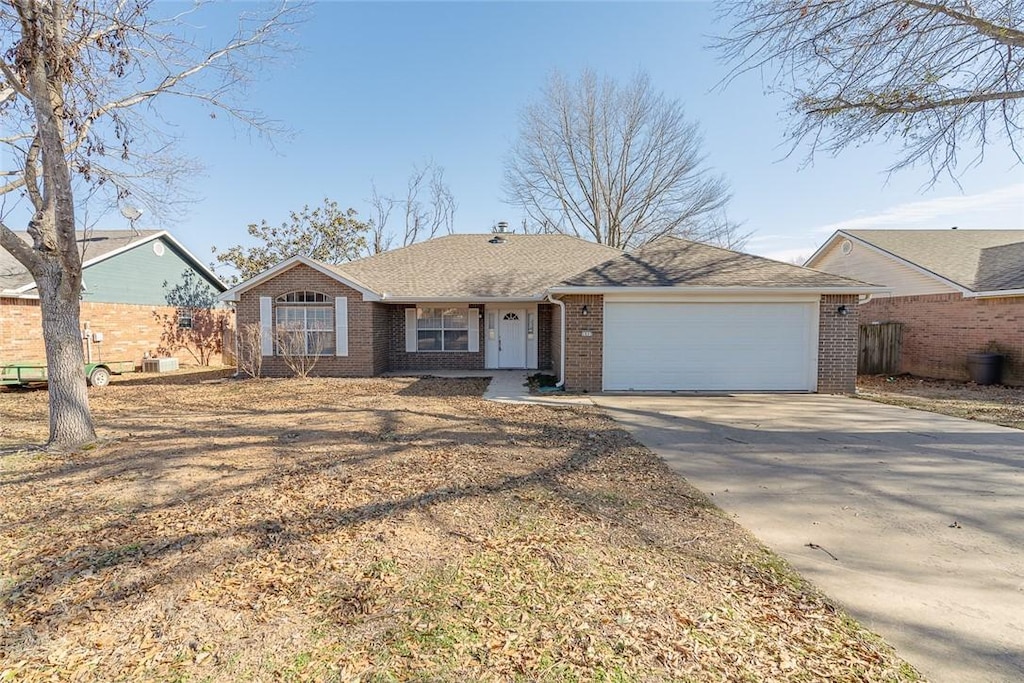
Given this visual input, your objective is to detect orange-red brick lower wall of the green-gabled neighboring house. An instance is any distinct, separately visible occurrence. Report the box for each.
[0,298,230,366]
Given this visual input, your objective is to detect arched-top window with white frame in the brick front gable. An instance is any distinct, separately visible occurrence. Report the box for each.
[273,291,335,355]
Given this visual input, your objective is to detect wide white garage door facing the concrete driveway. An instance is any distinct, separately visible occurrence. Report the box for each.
[604,301,817,391]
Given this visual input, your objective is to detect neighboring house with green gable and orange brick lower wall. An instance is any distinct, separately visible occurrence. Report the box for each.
[0,230,226,362]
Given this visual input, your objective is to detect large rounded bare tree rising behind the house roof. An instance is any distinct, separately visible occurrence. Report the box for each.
[505,71,735,249]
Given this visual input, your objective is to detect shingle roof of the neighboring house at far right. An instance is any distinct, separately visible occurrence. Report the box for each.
[841,230,1024,292]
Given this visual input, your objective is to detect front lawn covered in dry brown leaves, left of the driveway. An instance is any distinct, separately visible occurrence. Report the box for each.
[0,378,918,681]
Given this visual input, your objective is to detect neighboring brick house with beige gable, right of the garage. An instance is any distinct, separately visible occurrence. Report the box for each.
[806,229,1024,384]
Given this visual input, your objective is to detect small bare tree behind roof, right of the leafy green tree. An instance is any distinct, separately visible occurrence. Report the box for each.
[368,162,459,254]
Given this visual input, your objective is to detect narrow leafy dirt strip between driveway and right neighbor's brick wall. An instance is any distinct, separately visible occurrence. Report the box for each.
[857,375,1024,429]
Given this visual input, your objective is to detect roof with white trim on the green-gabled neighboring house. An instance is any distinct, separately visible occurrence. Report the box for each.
[0,230,226,296]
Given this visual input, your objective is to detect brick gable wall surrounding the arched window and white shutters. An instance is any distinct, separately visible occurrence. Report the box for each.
[236,263,381,377]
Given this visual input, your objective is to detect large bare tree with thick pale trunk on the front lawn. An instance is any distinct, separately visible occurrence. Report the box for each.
[0,0,296,449]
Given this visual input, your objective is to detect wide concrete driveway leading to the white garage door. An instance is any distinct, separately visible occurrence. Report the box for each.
[594,394,1024,682]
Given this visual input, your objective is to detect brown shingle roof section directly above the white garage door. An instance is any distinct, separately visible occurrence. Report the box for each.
[559,237,864,289]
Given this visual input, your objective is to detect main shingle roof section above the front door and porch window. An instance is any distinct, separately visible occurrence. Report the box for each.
[339,233,622,299]
